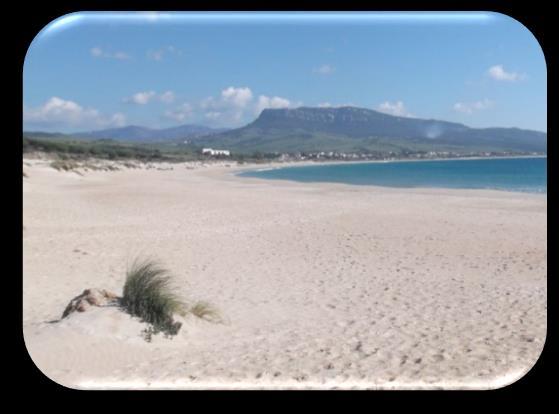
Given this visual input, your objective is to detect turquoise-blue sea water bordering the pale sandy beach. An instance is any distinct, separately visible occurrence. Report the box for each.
[240,157,547,193]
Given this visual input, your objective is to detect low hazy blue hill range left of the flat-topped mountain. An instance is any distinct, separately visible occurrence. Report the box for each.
[75,125,227,142]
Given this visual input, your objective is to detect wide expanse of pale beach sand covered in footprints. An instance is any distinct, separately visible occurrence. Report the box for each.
[23,160,547,388]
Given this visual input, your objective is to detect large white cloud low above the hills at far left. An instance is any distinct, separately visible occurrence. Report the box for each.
[23,96,126,129]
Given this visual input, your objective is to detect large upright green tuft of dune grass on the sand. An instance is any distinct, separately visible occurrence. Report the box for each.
[121,260,185,335]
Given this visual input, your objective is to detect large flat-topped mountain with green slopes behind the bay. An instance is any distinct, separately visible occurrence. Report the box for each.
[198,107,547,152]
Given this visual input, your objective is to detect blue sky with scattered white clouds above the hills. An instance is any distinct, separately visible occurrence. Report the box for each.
[23,12,547,132]
